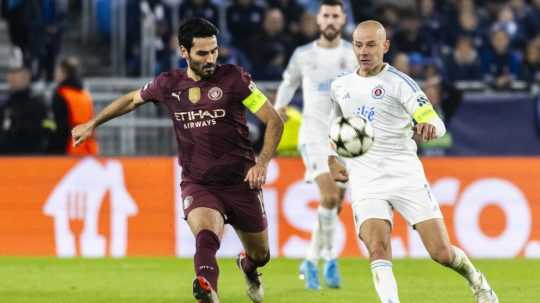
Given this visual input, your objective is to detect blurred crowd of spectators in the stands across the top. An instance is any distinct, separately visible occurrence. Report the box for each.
[1,0,540,89]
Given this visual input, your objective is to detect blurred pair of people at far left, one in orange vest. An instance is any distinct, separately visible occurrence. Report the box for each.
[0,50,98,155]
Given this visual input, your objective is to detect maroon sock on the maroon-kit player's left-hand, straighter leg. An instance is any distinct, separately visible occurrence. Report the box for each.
[194,229,219,292]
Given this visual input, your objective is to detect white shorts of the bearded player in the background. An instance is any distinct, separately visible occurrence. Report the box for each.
[300,143,330,182]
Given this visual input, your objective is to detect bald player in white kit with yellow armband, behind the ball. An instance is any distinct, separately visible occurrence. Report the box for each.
[329,21,499,303]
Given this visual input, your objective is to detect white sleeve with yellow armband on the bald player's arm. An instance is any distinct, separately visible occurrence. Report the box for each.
[399,78,446,137]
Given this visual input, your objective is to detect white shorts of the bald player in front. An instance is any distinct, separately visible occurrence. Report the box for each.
[352,183,443,233]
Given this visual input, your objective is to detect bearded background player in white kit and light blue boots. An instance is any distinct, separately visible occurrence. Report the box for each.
[275,0,356,290]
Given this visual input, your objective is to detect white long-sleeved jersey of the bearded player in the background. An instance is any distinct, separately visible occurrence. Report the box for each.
[275,39,357,145]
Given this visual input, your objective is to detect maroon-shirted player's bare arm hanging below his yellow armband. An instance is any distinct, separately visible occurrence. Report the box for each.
[244,101,283,188]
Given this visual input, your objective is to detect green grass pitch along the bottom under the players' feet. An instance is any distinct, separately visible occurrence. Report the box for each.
[0,257,540,303]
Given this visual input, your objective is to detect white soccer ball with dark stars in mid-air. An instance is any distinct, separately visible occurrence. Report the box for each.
[330,116,374,158]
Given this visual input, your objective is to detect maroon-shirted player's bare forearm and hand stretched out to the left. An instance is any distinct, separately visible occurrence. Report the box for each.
[71,90,145,146]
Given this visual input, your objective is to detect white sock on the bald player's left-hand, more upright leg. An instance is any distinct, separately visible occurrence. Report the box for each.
[371,259,399,303]
